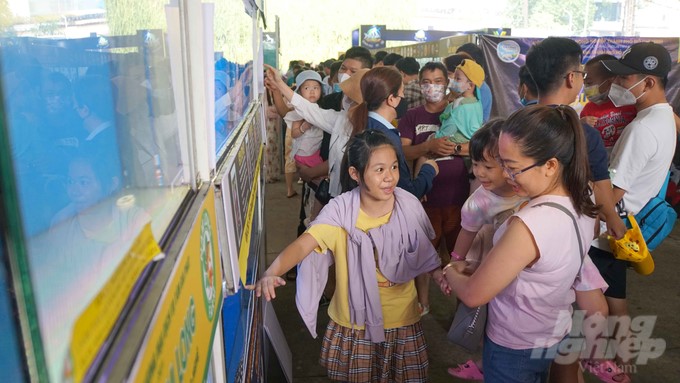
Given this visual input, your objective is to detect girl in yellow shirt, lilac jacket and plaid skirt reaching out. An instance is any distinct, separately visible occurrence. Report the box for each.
[247,129,441,382]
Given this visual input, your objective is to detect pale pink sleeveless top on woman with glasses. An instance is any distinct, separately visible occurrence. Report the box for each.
[486,196,599,350]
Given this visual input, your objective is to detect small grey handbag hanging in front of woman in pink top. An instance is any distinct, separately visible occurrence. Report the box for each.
[447,302,487,352]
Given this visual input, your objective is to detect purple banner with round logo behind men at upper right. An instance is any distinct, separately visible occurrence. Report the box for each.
[480,35,680,117]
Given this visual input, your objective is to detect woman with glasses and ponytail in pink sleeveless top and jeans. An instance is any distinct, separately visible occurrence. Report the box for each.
[442,105,606,383]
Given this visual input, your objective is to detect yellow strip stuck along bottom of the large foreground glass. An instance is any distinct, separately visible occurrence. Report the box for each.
[64,223,161,382]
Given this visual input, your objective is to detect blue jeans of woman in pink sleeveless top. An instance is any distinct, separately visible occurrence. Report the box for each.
[482,336,560,383]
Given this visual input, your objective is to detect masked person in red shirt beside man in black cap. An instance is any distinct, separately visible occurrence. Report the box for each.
[581,54,637,154]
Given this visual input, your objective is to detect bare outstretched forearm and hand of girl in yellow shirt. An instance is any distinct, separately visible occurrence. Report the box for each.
[245,233,319,301]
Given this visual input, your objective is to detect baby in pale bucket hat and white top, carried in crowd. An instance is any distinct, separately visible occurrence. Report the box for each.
[283,70,323,168]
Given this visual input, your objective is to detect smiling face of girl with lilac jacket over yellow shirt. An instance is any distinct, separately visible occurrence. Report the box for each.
[350,145,399,201]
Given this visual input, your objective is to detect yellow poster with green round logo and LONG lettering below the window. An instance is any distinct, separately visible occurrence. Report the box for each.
[132,186,222,383]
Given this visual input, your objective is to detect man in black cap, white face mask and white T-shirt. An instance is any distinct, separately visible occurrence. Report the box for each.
[590,42,677,356]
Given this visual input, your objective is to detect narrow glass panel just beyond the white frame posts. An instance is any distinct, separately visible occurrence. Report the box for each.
[215,0,254,153]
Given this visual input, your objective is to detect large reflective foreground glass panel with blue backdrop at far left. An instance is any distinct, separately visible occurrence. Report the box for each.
[0,0,190,382]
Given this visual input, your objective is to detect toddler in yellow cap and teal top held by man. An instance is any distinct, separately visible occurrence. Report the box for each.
[434,59,484,144]
